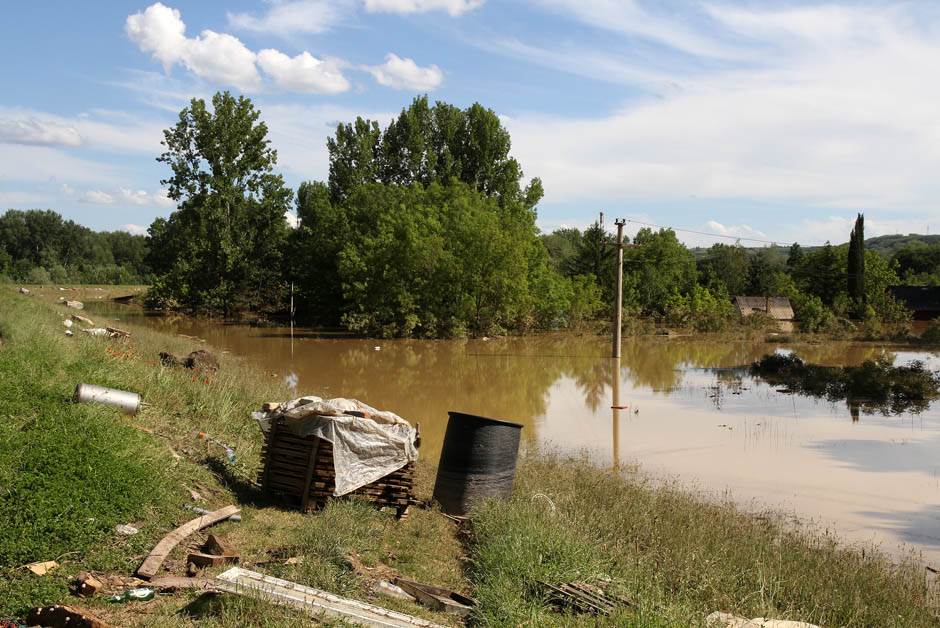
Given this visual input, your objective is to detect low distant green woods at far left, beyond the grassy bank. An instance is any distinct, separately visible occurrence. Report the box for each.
[0,209,150,284]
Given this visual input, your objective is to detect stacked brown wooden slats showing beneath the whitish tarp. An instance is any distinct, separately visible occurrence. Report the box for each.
[259,417,414,519]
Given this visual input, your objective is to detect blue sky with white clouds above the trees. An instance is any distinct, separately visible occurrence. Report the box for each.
[0,0,940,245]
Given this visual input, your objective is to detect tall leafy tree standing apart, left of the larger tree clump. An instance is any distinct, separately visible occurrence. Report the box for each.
[151,92,292,315]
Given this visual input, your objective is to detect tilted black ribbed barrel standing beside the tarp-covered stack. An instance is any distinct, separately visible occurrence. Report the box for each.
[434,412,522,516]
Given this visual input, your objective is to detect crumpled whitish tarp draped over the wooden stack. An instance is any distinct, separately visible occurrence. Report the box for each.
[252,397,418,496]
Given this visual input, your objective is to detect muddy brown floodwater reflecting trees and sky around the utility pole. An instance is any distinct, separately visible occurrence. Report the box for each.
[81,303,940,566]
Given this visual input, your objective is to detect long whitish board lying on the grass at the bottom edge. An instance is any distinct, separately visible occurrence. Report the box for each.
[216,567,438,628]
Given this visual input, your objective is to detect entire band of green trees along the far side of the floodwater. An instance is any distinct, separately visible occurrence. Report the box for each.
[0,92,940,337]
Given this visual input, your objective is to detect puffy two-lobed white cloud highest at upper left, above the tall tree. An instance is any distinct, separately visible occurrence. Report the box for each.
[124,2,261,91]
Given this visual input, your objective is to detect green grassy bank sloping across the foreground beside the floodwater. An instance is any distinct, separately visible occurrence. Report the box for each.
[0,286,940,626]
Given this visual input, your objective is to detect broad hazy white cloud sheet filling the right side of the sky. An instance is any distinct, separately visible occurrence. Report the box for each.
[506,7,940,216]
